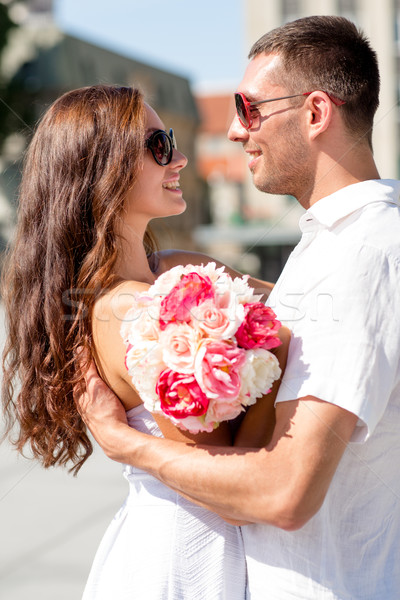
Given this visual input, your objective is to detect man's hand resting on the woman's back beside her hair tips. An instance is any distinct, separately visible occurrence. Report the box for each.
[75,361,129,462]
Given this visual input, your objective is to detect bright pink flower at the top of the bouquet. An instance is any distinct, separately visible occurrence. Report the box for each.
[160,273,214,330]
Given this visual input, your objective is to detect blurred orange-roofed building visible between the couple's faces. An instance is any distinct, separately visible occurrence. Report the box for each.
[194,91,299,281]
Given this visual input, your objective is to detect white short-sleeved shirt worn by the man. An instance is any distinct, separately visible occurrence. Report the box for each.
[243,180,400,600]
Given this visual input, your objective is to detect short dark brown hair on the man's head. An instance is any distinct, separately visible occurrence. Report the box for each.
[249,16,380,145]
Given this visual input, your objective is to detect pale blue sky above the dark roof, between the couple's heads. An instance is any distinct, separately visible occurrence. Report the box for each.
[54,0,247,91]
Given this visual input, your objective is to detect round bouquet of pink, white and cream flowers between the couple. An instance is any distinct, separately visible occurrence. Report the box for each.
[121,263,281,433]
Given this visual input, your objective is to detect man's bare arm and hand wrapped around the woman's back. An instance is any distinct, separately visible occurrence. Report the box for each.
[79,360,357,530]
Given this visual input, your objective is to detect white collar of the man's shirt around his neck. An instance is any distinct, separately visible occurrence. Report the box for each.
[299,179,400,231]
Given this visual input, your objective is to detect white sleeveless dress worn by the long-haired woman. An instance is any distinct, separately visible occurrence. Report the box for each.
[82,405,246,600]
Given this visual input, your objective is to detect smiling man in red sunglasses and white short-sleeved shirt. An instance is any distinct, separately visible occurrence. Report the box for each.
[82,17,400,600]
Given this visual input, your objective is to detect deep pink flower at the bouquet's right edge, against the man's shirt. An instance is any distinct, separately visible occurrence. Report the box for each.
[236,302,281,350]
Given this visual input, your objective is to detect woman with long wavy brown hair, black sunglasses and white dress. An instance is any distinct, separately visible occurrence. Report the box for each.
[3,85,288,600]
